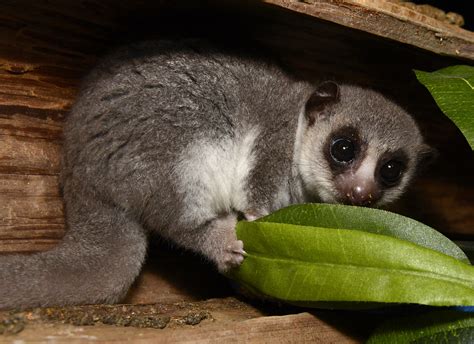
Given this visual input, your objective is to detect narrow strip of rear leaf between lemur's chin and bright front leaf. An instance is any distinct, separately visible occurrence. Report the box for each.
[257,203,469,263]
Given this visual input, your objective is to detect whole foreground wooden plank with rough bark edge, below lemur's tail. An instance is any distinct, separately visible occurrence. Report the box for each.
[0,298,365,343]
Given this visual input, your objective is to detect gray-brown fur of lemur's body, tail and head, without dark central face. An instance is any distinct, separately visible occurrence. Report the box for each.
[0,41,430,308]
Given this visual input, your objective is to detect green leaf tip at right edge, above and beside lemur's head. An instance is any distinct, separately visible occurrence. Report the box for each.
[415,65,474,149]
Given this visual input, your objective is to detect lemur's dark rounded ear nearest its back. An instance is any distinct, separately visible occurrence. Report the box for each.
[305,81,339,125]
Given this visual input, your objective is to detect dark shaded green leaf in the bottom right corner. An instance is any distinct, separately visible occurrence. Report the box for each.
[367,311,474,344]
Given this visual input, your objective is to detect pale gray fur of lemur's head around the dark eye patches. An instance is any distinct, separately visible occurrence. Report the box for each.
[297,85,433,206]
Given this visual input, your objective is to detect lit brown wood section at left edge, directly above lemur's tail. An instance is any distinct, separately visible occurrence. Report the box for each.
[0,113,64,252]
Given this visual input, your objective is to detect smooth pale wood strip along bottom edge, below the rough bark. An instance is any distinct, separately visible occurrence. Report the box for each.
[0,313,356,344]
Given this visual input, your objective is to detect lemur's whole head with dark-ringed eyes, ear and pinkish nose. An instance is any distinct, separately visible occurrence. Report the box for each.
[297,82,433,206]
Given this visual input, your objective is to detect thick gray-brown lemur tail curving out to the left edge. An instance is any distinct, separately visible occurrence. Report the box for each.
[0,195,147,309]
